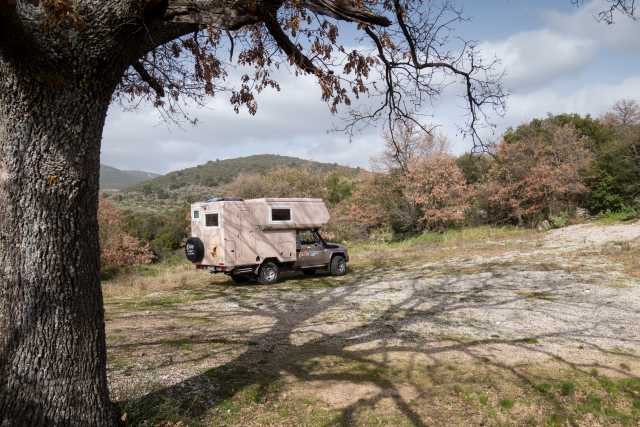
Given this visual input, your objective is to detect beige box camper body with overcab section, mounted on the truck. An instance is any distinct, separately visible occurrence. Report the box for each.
[191,198,329,271]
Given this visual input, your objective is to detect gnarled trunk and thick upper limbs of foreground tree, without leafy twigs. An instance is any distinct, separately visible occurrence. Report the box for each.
[0,0,388,427]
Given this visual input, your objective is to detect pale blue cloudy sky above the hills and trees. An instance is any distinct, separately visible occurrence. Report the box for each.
[101,0,640,173]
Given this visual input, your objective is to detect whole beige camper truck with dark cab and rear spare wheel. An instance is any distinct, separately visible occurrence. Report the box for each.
[185,198,349,284]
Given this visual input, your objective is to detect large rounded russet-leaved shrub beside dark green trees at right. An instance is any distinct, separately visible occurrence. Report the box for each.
[483,122,592,225]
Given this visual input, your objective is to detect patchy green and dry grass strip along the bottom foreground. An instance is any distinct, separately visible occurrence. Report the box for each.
[115,356,640,427]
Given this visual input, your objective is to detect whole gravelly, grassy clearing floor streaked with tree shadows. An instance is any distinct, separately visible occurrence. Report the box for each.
[105,222,640,426]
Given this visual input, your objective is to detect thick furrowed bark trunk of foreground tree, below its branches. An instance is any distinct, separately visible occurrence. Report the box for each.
[0,57,117,427]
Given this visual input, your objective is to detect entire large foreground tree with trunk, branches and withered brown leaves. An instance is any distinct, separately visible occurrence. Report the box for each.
[0,0,504,426]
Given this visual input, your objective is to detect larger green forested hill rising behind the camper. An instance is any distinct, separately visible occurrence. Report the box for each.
[129,154,356,192]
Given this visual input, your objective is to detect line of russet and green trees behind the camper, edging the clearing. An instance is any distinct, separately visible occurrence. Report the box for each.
[99,100,640,273]
